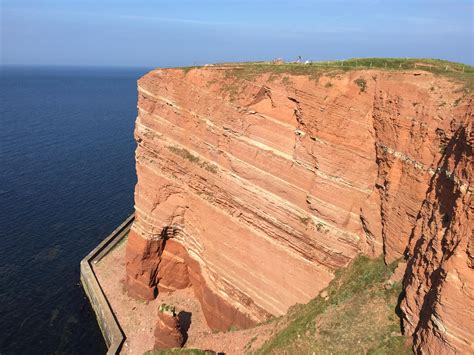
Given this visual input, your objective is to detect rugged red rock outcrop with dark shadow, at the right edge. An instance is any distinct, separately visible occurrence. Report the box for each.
[402,106,474,354]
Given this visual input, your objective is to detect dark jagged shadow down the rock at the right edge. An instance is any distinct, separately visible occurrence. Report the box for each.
[400,121,472,345]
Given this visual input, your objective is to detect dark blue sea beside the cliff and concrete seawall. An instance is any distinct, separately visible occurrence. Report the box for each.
[0,67,147,355]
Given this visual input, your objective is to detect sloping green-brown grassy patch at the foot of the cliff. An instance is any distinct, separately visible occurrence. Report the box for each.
[257,256,412,354]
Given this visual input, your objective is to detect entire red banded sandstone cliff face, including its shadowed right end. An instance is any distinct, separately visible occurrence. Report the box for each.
[127,66,474,348]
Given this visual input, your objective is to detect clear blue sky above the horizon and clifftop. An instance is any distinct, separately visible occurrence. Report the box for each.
[0,0,474,67]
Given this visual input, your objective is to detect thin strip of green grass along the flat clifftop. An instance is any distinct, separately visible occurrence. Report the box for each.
[181,58,474,92]
